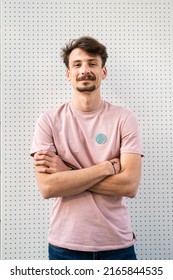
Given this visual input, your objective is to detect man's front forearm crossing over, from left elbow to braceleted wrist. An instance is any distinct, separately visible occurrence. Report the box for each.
[36,161,113,198]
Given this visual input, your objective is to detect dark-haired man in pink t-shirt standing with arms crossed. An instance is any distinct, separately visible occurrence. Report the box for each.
[31,37,143,260]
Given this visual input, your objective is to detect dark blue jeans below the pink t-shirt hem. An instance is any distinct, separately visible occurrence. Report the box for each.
[49,244,136,260]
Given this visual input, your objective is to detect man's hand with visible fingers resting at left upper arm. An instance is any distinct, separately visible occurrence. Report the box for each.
[34,151,71,174]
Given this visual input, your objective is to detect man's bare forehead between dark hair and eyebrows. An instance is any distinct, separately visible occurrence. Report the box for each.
[69,48,101,63]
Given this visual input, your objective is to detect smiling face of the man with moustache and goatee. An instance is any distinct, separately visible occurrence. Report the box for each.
[66,48,107,92]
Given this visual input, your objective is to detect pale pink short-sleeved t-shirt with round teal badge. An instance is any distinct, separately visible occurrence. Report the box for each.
[31,101,143,251]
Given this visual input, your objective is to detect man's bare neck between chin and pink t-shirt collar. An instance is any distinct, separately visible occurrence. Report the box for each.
[72,93,102,112]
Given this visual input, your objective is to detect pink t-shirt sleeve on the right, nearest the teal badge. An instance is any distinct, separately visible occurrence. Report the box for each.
[120,111,144,156]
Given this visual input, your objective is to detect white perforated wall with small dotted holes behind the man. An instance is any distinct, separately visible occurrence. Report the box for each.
[1,0,173,259]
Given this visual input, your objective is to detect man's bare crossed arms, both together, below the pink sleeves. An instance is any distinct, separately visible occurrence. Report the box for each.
[34,151,141,199]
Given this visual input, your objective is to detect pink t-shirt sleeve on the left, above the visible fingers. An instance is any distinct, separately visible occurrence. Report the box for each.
[30,114,56,156]
